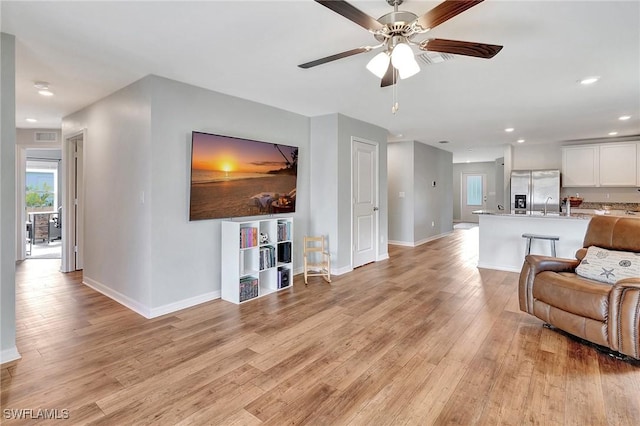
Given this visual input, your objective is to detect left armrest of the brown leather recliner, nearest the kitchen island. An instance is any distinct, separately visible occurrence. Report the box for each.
[518,254,580,314]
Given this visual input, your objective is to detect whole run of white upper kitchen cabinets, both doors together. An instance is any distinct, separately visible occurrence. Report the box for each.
[562,142,640,187]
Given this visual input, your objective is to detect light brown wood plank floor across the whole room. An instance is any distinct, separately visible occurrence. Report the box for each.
[0,228,640,425]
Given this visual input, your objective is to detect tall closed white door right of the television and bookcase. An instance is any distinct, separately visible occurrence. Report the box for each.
[352,140,378,268]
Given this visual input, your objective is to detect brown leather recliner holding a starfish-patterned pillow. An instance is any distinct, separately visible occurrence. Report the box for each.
[518,216,640,359]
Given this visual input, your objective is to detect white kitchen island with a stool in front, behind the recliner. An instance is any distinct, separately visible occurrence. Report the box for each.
[478,213,591,272]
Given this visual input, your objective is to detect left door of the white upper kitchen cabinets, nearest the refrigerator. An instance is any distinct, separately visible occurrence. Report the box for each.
[562,145,600,187]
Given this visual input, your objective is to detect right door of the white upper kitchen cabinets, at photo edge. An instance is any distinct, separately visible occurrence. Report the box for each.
[599,142,638,186]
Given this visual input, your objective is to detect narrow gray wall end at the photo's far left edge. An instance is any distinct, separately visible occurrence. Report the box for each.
[0,33,20,363]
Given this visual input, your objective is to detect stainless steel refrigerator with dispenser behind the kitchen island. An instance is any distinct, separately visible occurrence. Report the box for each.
[511,170,560,214]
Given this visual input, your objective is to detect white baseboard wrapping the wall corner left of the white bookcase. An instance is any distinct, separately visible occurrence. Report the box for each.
[82,276,221,319]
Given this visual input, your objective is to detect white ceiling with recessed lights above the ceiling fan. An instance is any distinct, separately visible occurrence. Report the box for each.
[1,0,640,162]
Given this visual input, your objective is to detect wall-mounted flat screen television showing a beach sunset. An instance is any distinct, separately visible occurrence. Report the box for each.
[189,132,298,221]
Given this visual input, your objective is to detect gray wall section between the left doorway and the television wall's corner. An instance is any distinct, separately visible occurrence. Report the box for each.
[62,78,154,311]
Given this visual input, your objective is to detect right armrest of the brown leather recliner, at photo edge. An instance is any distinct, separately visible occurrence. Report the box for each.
[608,278,640,359]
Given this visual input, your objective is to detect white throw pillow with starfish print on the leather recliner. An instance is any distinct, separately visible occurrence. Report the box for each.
[576,246,640,284]
